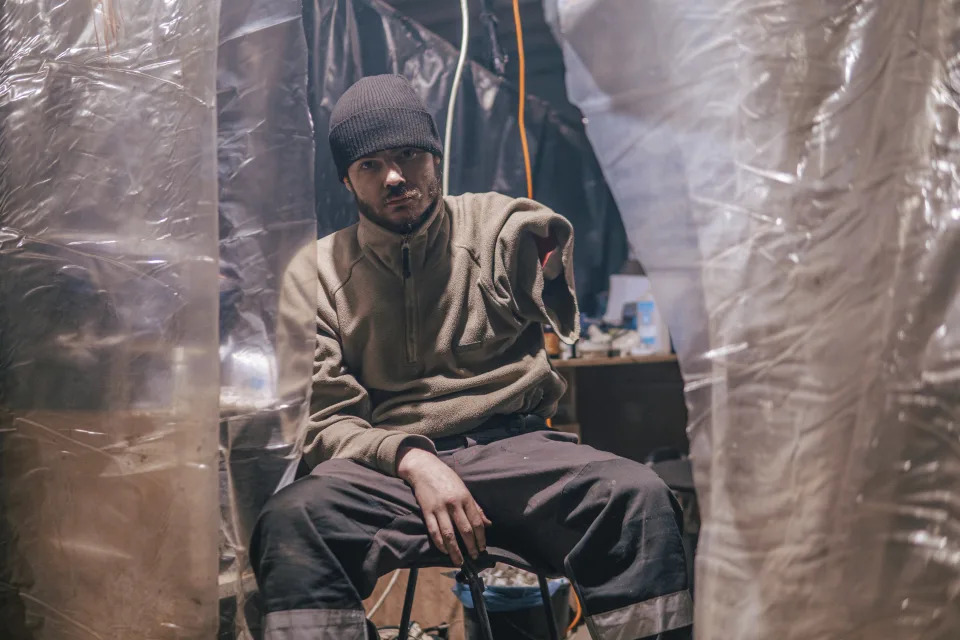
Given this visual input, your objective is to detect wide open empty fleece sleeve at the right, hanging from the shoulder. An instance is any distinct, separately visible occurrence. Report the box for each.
[491,198,580,344]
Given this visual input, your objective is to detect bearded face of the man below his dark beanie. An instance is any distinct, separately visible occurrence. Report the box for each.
[344,147,441,233]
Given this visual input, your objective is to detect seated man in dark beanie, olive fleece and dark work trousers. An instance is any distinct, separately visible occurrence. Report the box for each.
[251,76,692,640]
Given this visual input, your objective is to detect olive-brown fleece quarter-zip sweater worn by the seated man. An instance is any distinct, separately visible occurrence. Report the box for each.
[300,193,580,475]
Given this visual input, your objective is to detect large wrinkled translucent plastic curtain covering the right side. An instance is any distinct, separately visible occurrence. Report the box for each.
[547,0,960,640]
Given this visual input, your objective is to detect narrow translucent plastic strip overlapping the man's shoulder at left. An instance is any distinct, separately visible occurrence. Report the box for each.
[217,0,317,638]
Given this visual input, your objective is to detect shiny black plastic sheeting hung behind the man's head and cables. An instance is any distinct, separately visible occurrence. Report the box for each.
[304,0,627,314]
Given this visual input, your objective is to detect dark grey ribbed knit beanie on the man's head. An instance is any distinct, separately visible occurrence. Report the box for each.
[330,75,443,180]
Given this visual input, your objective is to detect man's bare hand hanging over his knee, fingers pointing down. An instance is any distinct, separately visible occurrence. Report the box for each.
[397,447,492,567]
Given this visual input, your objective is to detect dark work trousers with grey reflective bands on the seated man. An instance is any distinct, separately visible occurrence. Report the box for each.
[251,416,693,640]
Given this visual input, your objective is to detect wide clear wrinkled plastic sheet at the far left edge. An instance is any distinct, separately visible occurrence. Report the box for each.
[0,0,219,640]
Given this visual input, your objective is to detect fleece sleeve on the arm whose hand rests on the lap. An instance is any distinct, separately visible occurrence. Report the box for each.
[303,286,436,475]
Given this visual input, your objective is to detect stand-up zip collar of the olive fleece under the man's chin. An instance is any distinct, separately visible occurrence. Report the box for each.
[357,198,450,278]
